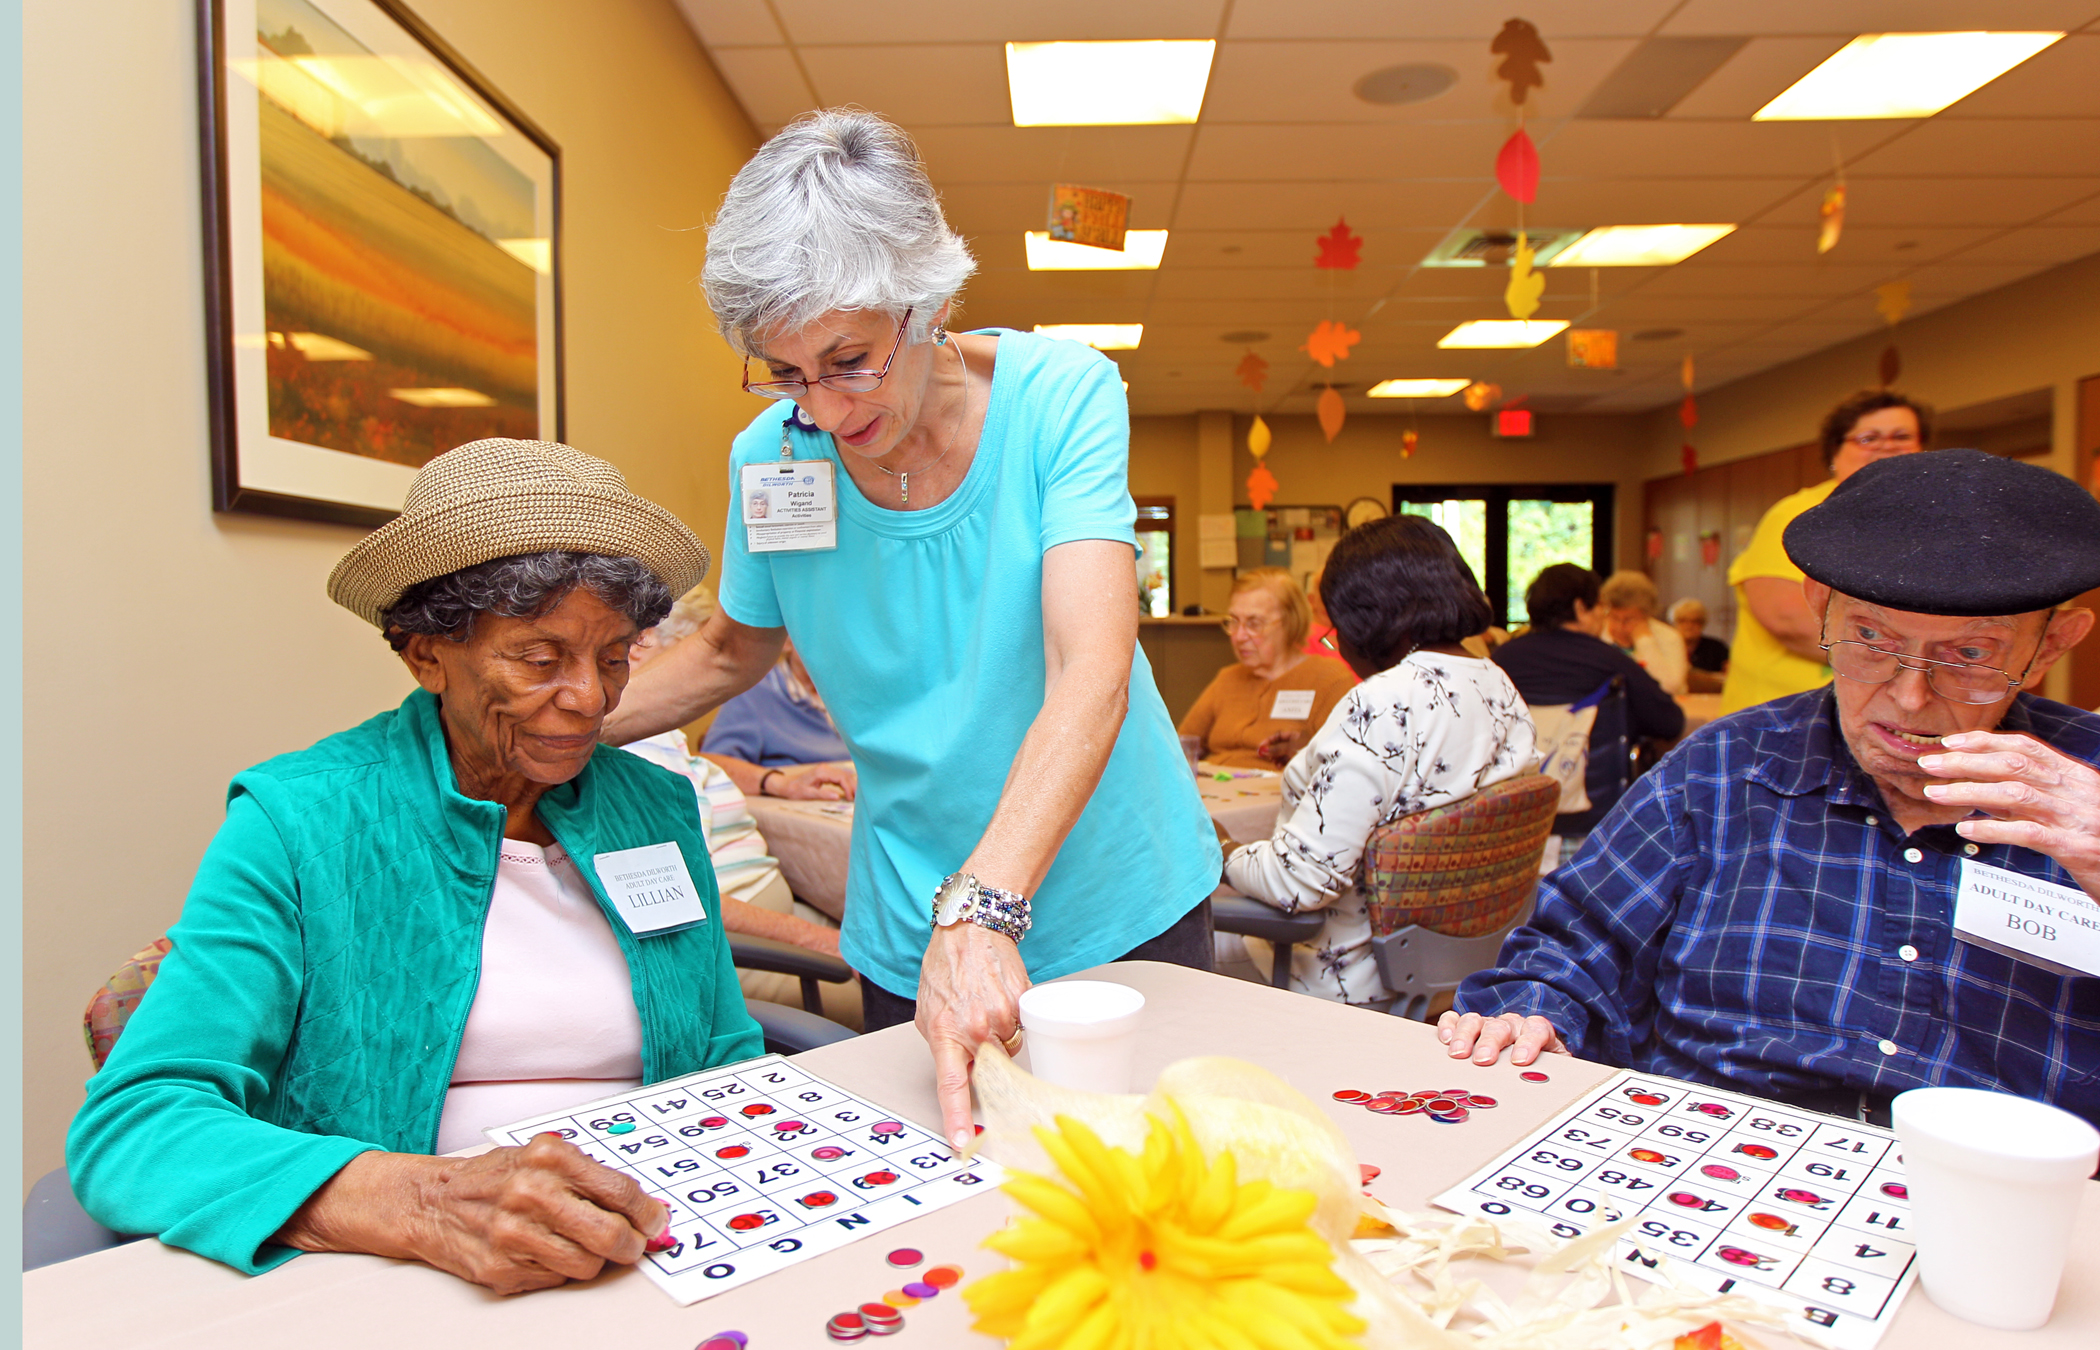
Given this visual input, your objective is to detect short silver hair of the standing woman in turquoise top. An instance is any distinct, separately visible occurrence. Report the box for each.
[699,107,977,355]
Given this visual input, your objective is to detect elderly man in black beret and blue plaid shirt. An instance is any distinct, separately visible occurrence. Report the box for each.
[1439,449,2100,1123]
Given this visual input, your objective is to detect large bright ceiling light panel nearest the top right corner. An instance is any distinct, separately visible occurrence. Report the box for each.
[1749,34,2062,122]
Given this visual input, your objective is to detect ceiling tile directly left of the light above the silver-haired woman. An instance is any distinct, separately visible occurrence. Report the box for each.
[800,42,1014,128]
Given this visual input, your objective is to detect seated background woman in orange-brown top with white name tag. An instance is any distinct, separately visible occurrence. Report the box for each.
[1180,567,1357,768]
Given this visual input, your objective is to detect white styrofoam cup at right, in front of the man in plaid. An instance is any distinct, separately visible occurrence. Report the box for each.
[1890,1088,2100,1331]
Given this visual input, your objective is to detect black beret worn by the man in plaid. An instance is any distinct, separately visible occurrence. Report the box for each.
[1785,449,2100,617]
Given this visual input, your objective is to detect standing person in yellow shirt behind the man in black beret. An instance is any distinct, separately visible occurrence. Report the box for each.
[1720,388,1932,712]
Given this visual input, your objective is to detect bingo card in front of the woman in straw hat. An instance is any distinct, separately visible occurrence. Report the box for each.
[485,1054,1006,1304]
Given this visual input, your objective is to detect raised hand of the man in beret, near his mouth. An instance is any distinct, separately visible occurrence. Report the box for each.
[1917,731,2100,899]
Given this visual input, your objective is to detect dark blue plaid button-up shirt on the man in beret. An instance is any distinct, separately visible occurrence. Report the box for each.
[1457,689,2100,1123]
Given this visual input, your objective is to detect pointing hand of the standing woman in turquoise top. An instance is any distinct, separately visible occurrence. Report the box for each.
[916,924,1029,1148]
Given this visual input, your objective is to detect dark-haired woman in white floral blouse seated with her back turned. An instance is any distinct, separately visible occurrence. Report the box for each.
[1224,516,1537,1010]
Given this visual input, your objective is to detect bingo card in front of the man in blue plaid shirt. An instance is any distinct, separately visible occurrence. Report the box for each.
[1434,1071,1915,1350]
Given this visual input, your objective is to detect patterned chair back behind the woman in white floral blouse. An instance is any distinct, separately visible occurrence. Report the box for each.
[1365,773,1560,938]
